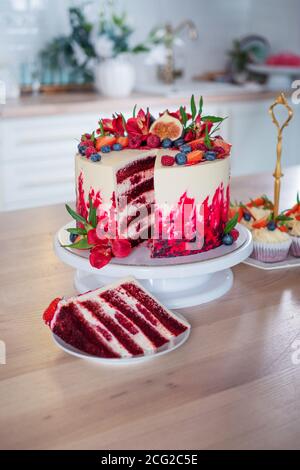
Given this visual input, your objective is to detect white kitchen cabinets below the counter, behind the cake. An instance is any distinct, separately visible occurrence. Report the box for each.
[0,94,300,210]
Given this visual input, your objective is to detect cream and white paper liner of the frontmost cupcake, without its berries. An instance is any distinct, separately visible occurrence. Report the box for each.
[251,227,292,263]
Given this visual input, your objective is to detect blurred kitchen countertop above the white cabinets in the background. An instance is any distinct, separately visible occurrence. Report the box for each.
[0,87,286,118]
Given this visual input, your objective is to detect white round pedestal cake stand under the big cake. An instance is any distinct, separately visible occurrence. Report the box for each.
[54,223,253,308]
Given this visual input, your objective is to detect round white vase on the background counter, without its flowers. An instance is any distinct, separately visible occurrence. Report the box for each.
[95,57,135,98]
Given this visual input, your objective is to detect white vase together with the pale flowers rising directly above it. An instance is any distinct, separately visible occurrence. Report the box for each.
[94,10,148,98]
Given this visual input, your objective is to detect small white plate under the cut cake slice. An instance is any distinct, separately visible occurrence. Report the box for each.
[52,313,191,366]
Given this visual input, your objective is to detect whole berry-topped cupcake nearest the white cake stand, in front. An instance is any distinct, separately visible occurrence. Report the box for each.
[251,214,292,263]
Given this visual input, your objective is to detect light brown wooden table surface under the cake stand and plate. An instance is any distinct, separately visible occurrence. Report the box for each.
[0,167,300,449]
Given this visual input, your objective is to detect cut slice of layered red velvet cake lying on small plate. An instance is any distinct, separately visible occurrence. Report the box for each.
[43,278,190,358]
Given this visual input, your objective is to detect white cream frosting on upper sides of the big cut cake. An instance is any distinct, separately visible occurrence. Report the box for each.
[75,149,230,212]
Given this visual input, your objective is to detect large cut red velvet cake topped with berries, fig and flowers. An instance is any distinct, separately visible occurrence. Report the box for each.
[64,97,236,268]
